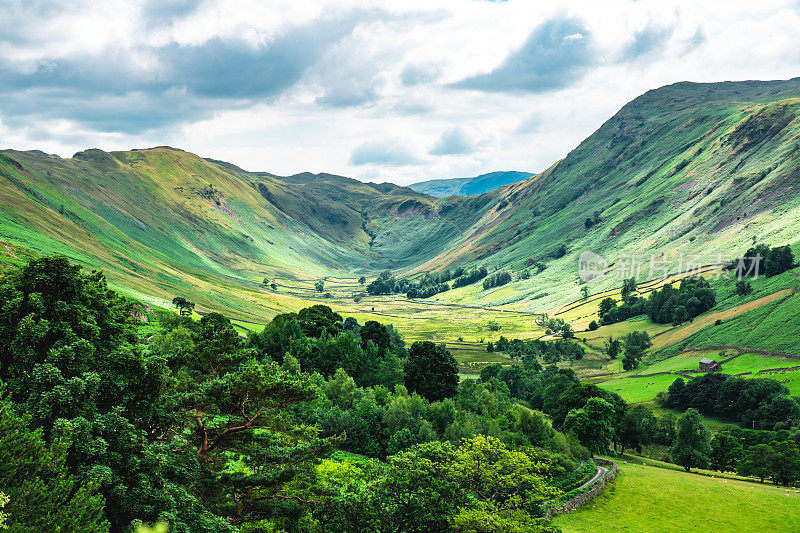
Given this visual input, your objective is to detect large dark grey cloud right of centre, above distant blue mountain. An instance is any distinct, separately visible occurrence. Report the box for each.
[453,18,594,93]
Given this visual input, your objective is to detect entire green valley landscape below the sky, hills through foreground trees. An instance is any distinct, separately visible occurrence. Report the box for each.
[0,79,800,532]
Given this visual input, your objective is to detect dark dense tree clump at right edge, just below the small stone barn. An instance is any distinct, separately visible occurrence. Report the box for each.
[658,372,800,430]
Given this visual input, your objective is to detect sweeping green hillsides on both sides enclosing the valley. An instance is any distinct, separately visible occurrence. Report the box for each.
[0,79,800,324]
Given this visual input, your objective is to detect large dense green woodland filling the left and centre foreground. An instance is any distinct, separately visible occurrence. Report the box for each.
[0,257,587,533]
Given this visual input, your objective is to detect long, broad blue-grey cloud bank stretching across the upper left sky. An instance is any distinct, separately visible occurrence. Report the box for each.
[0,14,359,133]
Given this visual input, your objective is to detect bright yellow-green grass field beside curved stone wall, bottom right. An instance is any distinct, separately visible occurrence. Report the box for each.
[553,463,800,533]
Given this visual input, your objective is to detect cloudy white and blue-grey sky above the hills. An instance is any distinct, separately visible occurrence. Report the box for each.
[0,0,800,184]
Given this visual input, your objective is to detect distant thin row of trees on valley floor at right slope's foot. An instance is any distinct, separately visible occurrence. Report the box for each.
[367,267,488,298]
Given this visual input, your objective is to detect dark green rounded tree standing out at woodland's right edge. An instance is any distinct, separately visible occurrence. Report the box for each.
[405,341,458,401]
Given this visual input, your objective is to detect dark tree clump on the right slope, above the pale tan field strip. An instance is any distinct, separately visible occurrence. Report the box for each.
[598,277,716,325]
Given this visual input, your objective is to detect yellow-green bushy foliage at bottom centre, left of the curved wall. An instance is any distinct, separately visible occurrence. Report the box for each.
[315,436,563,533]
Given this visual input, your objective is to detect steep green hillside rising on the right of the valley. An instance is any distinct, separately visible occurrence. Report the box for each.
[418,79,800,310]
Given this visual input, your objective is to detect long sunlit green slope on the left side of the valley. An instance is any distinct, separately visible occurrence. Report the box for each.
[0,147,500,304]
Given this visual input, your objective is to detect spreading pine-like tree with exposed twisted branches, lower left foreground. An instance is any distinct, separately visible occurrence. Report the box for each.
[175,313,335,525]
